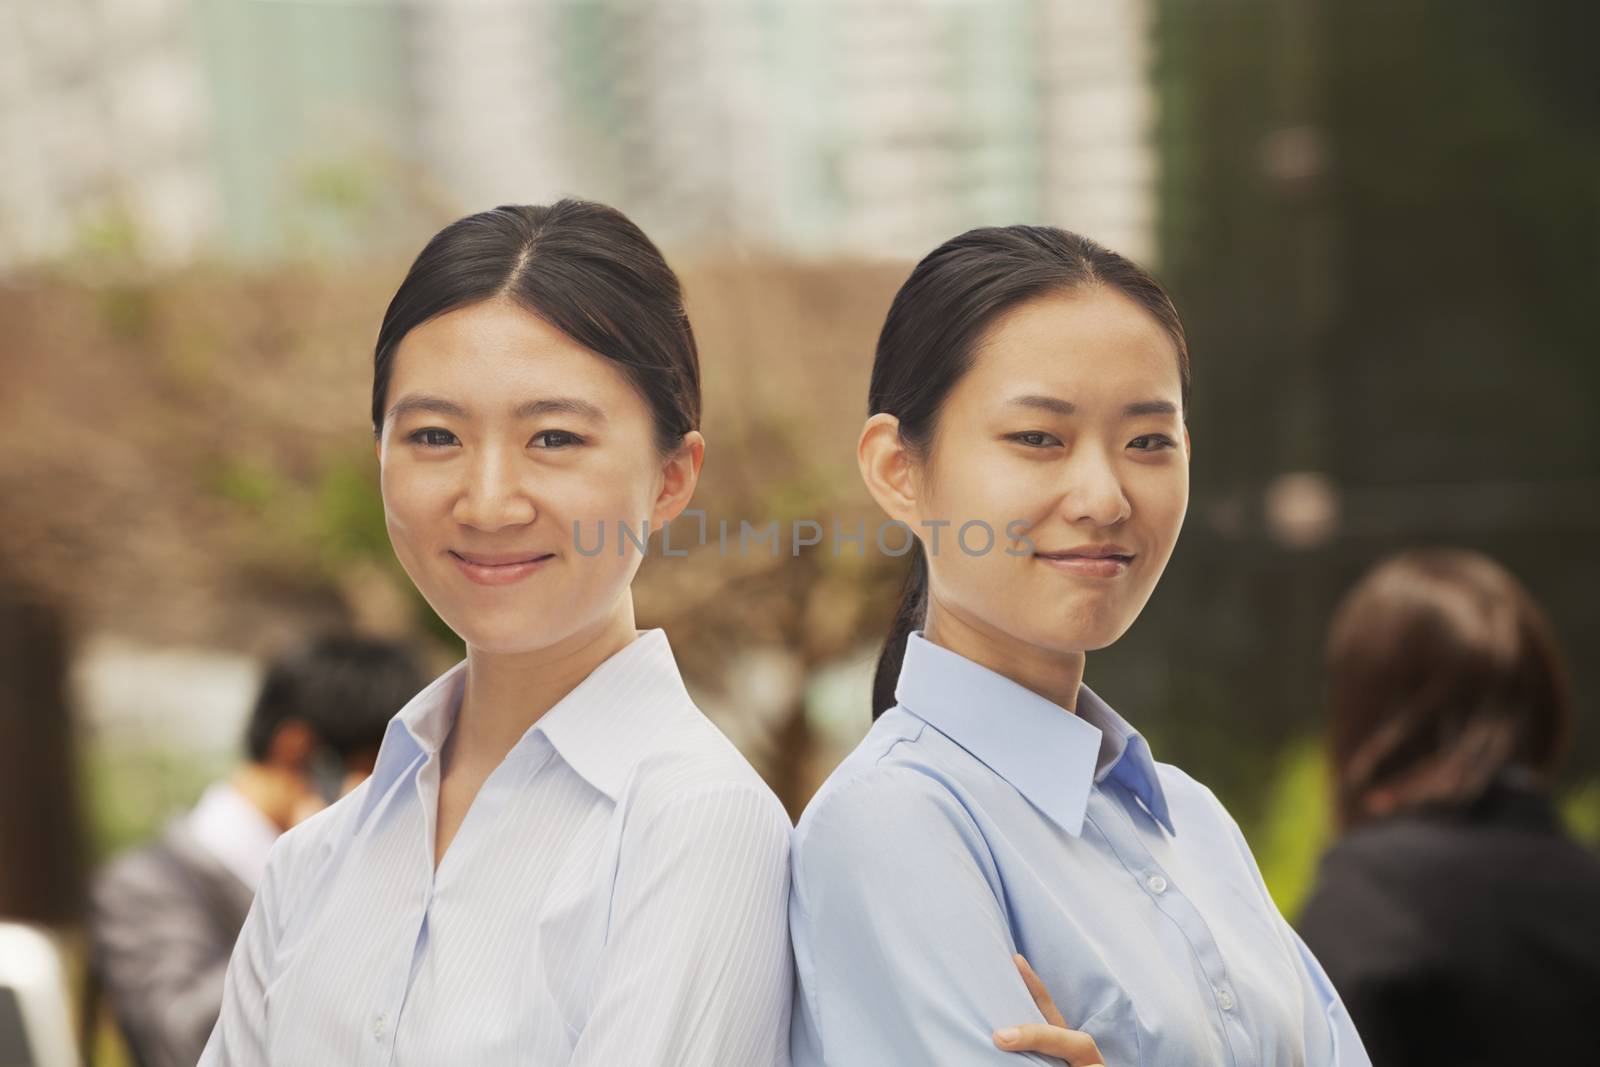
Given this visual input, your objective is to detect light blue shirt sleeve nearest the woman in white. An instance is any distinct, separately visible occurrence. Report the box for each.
[789,766,1059,1067]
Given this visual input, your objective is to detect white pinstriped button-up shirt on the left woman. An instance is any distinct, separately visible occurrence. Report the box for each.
[200,630,792,1067]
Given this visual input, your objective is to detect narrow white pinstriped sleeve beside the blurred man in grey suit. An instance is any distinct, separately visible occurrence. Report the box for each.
[198,830,293,1067]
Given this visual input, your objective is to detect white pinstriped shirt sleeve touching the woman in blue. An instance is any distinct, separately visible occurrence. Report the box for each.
[571,784,794,1067]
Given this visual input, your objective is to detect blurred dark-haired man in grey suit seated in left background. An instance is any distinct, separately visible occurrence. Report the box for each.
[91,635,427,1067]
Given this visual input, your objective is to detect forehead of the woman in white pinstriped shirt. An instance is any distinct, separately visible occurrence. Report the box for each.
[389,301,632,400]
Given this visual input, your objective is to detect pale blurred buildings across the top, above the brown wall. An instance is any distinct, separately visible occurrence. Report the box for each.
[0,0,1155,262]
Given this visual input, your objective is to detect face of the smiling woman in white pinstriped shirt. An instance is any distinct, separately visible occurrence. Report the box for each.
[378,301,701,653]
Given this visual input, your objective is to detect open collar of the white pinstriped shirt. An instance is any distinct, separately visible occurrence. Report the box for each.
[355,629,693,829]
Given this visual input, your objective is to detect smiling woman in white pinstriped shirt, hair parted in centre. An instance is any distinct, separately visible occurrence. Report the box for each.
[202,200,794,1067]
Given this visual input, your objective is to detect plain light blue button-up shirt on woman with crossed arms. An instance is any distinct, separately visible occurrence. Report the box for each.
[789,633,1368,1067]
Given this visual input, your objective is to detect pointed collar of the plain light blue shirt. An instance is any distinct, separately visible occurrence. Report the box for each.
[894,630,1176,837]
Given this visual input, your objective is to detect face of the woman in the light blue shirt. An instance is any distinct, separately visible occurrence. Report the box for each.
[883,288,1189,653]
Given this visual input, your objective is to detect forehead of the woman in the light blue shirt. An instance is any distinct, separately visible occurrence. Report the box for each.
[958,286,1182,406]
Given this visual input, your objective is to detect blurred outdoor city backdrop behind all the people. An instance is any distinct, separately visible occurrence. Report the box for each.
[0,0,1600,1062]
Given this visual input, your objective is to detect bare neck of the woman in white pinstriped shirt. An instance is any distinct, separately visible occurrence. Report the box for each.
[443,592,638,771]
